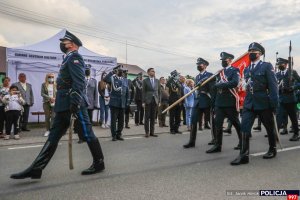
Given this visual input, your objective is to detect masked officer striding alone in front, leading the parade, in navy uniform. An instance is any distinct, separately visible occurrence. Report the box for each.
[11,31,105,179]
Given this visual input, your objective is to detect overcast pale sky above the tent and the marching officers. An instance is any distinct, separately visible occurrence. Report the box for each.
[0,0,300,76]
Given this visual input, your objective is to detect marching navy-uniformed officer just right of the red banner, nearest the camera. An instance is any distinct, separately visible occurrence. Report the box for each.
[231,42,278,165]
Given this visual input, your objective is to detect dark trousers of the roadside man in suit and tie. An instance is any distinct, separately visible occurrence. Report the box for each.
[144,97,157,135]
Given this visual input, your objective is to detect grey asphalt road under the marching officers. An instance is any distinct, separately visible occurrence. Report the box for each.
[0,130,300,200]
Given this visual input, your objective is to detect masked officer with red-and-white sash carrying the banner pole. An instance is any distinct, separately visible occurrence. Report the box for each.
[206,52,241,153]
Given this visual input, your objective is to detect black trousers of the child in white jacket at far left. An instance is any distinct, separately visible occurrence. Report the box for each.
[5,110,21,135]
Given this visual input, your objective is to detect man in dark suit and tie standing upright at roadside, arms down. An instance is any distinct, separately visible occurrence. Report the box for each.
[143,68,160,137]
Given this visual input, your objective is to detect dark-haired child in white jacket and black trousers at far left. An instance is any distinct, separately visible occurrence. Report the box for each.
[2,85,25,140]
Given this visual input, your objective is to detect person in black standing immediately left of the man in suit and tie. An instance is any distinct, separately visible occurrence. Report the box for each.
[132,72,144,126]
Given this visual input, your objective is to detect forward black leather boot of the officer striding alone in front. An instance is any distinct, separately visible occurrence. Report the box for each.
[10,140,57,179]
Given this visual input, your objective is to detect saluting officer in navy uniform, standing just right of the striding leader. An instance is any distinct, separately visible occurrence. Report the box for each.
[104,65,129,141]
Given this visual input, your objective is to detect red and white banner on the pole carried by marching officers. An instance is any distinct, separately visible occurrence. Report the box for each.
[231,52,250,109]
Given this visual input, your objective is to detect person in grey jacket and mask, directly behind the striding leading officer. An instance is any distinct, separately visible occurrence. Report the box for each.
[85,65,98,124]
